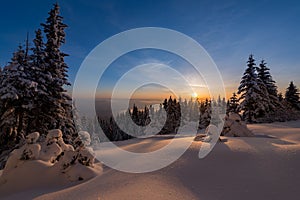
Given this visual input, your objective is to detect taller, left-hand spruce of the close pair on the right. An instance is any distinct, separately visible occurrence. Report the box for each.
[238,55,269,123]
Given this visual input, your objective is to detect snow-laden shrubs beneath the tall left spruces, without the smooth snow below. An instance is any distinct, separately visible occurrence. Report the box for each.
[0,129,102,183]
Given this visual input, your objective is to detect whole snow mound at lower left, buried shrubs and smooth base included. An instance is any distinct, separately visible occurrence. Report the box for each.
[0,129,102,196]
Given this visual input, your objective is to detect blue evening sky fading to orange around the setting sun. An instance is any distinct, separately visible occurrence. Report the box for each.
[0,0,300,98]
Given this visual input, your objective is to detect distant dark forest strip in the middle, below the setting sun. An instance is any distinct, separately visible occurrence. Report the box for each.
[78,96,227,143]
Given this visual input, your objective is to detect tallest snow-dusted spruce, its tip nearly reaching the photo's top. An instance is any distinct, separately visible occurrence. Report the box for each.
[41,3,77,143]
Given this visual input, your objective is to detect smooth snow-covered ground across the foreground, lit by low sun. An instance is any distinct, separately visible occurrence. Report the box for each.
[0,121,300,200]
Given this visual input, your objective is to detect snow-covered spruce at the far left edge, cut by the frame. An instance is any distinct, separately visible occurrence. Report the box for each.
[0,43,37,149]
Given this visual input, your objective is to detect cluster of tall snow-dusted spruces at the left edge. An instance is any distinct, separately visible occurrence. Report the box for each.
[0,3,76,153]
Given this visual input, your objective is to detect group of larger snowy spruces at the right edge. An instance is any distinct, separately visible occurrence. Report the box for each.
[234,55,300,123]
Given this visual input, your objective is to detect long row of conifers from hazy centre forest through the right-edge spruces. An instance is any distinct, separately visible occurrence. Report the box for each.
[80,55,300,141]
